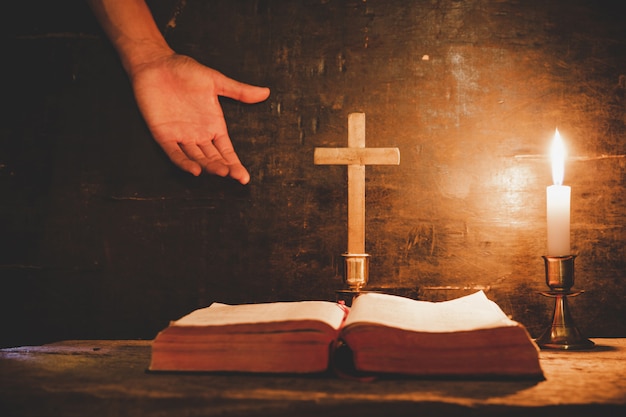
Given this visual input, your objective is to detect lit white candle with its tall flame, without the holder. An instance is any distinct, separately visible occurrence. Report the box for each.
[547,129,571,256]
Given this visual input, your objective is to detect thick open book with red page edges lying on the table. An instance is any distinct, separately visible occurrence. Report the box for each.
[149,291,543,378]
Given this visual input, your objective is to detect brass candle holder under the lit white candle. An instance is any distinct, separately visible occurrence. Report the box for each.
[535,255,595,350]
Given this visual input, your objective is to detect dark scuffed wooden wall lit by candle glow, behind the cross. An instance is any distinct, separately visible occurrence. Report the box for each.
[0,0,626,345]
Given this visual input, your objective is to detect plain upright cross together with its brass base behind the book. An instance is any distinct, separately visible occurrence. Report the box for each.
[313,113,400,291]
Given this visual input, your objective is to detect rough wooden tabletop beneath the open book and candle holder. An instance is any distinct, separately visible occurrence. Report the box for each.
[0,339,626,417]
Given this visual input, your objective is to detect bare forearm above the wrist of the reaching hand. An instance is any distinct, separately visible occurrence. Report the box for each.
[87,0,174,77]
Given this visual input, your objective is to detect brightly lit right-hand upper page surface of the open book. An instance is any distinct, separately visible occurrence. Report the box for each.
[345,291,517,333]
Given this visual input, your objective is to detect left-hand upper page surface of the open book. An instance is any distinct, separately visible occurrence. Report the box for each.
[172,301,345,329]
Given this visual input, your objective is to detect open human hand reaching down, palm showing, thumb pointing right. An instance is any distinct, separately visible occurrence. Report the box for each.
[130,53,270,184]
